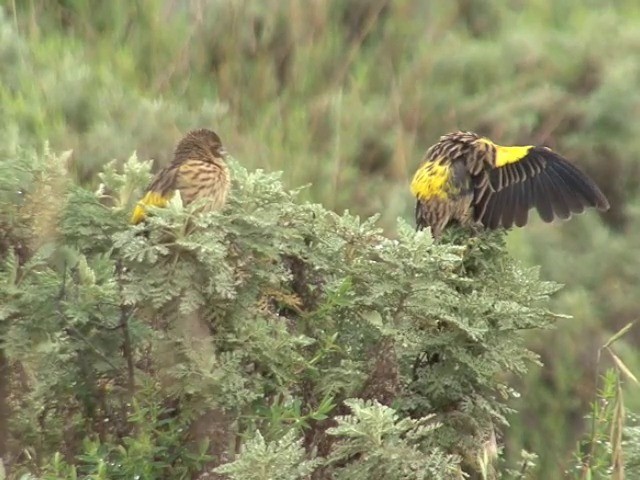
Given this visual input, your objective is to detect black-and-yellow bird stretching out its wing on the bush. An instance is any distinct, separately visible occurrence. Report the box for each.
[411,132,609,238]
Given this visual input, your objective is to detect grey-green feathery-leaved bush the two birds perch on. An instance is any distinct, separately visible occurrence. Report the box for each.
[0,153,557,480]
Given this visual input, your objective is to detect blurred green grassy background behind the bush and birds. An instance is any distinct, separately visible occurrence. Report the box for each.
[0,0,640,478]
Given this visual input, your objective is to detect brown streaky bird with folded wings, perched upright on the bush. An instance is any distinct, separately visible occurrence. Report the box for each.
[131,129,231,224]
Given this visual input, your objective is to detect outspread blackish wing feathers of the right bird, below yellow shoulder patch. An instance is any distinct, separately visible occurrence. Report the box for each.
[474,147,609,229]
